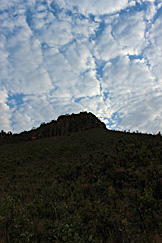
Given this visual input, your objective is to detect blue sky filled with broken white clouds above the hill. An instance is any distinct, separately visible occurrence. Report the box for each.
[0,0,162,133]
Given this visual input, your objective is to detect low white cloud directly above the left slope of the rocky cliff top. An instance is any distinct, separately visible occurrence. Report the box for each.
[12,95,82,132]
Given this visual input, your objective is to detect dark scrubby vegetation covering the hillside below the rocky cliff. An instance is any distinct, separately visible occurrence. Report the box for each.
[0,113,162,243]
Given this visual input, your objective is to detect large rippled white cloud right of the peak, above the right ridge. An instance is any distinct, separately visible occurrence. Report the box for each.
[102,56,157,131]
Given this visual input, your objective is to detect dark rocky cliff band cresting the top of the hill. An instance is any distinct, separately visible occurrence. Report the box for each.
[0,112,106,144]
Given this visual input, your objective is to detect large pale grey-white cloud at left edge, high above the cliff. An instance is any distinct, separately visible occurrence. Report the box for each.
[1,11,52,93]
